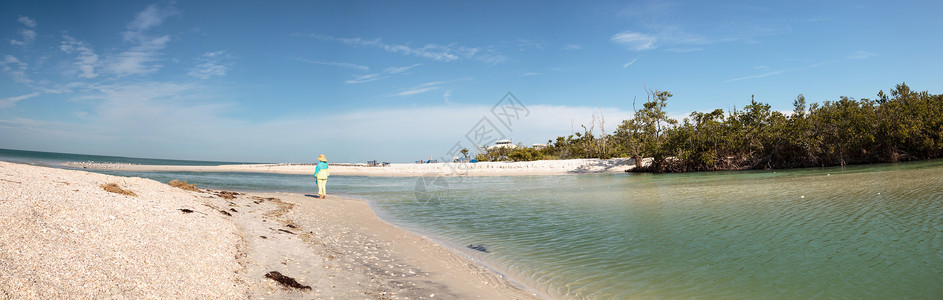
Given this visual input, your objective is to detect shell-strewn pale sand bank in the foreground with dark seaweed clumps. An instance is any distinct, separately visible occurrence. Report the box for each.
[0,162,537,299]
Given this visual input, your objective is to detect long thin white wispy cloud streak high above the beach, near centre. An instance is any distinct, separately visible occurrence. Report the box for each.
[308,34,509,64]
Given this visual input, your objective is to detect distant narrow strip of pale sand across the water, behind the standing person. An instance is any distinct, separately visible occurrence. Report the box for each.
[65,158,651,176]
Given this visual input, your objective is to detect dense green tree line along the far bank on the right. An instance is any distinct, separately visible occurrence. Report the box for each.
[477,83,943,172]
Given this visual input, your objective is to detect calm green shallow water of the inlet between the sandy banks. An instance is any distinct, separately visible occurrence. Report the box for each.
[1,149,943,299]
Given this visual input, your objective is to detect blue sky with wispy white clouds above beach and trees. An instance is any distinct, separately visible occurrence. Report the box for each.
[0,0,943,163]
